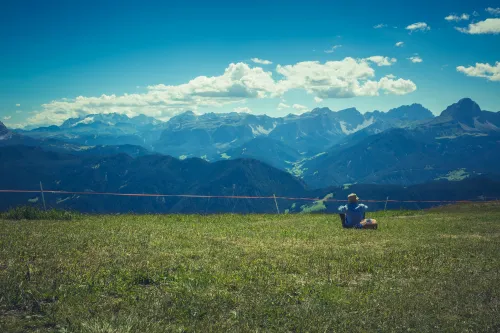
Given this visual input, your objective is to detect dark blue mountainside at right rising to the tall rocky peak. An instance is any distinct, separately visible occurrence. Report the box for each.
[303,98,500,187]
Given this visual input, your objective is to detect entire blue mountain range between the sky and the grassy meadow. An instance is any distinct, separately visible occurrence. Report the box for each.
[0,98,500,212]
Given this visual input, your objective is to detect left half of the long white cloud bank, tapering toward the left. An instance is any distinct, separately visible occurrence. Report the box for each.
[29,63,276,124]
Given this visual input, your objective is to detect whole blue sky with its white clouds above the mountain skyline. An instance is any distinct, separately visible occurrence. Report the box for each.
[0,0,500,127]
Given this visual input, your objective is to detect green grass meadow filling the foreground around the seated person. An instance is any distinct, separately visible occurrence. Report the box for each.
[0,205,500,332]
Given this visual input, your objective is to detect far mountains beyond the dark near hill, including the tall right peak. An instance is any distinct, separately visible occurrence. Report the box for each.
[5,98,500,192]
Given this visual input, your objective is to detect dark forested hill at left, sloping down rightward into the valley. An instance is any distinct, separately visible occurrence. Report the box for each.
[0,146,304,213]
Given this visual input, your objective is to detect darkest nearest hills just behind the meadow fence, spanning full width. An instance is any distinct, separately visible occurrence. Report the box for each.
[0,146,500,213]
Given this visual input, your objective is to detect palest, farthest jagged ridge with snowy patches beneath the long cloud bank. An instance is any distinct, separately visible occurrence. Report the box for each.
[13,104,433,161]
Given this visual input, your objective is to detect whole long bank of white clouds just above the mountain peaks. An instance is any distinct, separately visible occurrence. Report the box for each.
[27,56,414,125]
